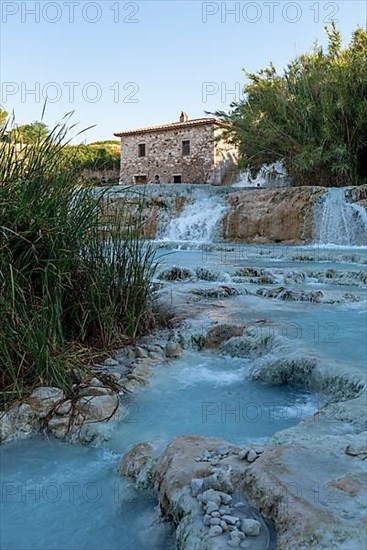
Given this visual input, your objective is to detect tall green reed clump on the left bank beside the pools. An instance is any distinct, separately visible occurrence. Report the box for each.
[0,115,156,406]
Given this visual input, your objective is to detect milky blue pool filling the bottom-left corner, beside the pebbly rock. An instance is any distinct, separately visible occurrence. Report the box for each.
[0,438,174,550]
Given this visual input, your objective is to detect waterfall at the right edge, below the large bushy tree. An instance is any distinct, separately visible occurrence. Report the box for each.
[315,187,367,246]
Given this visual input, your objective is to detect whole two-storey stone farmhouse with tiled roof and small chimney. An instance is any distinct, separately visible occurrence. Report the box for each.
[115,112,237,185]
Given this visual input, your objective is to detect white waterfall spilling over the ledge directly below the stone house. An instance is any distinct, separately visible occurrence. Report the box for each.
[161,196,226,243]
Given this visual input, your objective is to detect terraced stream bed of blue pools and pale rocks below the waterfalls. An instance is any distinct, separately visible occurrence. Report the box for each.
[0,188,367,550]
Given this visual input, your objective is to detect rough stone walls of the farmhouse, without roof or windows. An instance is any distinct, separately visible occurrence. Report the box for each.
[120,124,234,185]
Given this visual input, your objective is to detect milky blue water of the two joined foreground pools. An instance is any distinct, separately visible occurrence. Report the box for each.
[0,352,318,550]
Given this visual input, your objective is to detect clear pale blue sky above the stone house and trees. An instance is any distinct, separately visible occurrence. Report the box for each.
[0,0,367,141]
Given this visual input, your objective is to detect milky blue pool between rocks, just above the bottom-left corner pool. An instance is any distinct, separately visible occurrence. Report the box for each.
[109,352,318,453]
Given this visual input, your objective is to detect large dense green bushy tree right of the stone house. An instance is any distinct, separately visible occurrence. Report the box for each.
[216,25,367,186]
